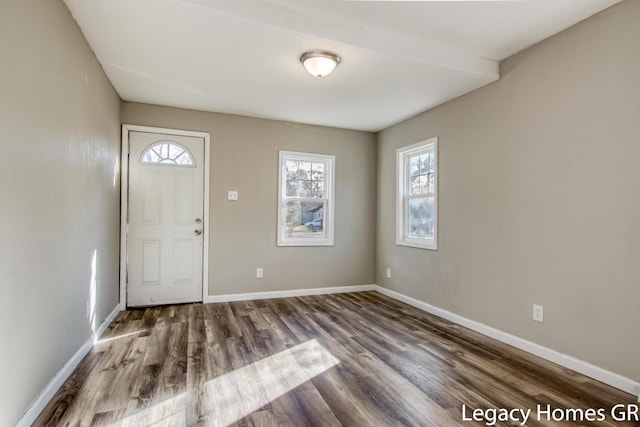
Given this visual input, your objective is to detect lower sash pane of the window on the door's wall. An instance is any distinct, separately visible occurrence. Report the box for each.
[282,200,326,238]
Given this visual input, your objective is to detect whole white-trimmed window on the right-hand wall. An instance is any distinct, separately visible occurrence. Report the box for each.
[396,137,438,250]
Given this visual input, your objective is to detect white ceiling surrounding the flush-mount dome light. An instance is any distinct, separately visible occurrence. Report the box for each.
[64,0,620,131]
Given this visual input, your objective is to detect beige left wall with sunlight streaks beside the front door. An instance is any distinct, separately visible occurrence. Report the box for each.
[0,0,120,426]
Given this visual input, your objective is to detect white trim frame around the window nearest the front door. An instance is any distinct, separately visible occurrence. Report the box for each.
[277,150,336,246]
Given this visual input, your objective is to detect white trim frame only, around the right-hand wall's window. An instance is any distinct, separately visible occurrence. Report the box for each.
[396,137,439,250]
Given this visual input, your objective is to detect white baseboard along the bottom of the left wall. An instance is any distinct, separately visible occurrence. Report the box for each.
[16,304,121,427]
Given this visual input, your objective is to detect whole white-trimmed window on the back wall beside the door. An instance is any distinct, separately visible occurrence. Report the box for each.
[278,151,335,246]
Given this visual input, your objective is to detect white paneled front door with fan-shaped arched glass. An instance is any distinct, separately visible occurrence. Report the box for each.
[127,131,205,307]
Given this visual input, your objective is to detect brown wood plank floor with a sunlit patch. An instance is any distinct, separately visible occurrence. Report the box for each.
[34,292,640,427]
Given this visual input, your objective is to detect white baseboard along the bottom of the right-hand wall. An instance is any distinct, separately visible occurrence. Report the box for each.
[375,285,640,396]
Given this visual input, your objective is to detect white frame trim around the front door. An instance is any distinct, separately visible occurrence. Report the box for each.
[119,123,211,310]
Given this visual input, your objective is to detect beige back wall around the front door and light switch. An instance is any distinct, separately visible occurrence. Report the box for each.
[122,102,376,295]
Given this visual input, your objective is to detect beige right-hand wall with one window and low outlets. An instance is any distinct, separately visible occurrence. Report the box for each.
[377,1,640,380]
